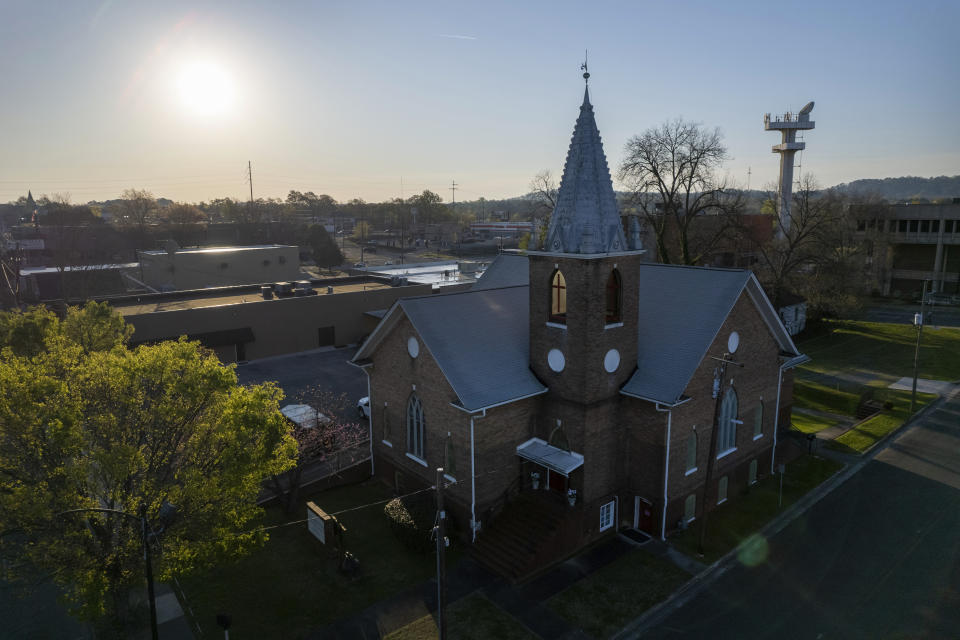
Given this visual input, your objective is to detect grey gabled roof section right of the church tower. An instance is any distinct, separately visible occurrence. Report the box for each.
[621,263,798,404]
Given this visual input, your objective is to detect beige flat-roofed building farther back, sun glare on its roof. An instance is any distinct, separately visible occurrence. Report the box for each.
[139,244,301,291]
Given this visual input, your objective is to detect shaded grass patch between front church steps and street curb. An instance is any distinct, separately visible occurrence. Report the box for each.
[544,549,690,638]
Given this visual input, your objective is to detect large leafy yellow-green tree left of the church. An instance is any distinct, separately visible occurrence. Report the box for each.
[0,305,296,636]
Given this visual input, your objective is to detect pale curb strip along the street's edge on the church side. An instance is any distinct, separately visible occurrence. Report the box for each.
[611,388,960,640]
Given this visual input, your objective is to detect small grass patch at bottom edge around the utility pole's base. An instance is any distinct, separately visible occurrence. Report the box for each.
[383,594,537,640]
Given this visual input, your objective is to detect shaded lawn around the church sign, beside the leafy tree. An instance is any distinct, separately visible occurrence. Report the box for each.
[181,481,458,639]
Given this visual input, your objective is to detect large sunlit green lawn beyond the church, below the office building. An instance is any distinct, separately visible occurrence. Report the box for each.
[799,320,960,380]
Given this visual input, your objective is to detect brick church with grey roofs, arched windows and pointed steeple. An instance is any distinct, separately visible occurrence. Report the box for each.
[354,76,806,578]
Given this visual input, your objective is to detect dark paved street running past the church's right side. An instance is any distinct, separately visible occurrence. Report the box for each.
[641,394,960,640]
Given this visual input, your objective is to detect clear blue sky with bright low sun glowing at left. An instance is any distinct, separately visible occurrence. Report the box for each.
[0,0,960,203]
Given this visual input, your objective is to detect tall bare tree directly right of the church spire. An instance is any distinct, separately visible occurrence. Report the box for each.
[618,119,743,264]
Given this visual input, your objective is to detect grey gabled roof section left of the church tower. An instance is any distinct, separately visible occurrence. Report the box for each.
[353,286,547,411]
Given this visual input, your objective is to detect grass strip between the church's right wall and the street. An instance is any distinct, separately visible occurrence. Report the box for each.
[670,455,843,564]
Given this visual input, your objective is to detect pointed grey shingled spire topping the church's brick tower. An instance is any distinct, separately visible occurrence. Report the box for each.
[544,72,629,254]
